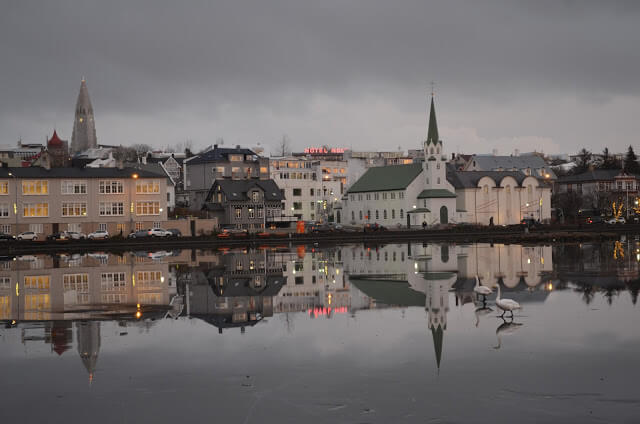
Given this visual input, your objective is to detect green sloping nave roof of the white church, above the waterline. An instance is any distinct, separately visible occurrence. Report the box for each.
[347,163,422,193]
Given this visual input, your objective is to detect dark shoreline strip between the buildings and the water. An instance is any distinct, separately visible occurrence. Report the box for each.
[0,224,640,256]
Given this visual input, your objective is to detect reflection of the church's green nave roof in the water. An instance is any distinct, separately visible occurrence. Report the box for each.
[350,278,426,306]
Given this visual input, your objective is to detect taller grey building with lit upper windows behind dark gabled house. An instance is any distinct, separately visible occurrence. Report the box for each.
[183,144,269,210]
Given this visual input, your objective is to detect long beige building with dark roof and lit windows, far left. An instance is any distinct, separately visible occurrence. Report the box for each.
[0,167,167,236]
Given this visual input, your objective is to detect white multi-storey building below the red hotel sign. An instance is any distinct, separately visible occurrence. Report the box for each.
[269,156,347,222]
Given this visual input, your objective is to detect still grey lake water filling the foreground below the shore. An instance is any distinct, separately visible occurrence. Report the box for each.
[0,238,640,423]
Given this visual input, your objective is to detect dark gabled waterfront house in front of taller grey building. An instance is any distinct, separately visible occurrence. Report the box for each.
[202,179,284,230]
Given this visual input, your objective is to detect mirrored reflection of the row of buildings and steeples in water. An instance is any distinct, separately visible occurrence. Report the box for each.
[0,239,640,381]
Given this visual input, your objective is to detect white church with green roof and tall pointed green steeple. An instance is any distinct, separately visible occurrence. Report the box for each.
[343,96,463,227]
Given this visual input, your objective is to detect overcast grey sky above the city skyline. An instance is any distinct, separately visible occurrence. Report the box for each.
[0,0,640,154]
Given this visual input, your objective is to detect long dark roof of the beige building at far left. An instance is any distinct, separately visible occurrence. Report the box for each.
[0,166,166,178]
